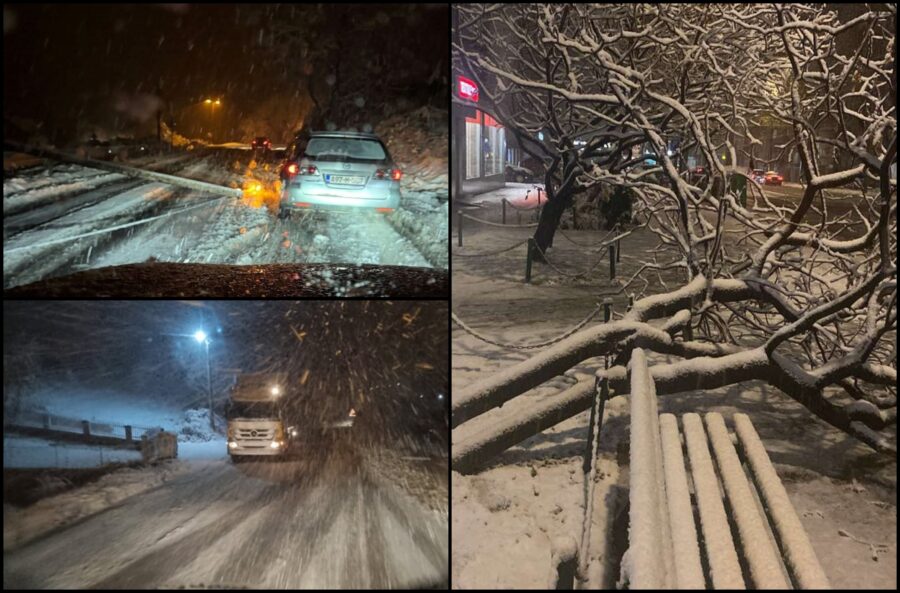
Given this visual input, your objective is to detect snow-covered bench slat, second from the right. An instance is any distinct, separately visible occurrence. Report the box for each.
[706,413,790,589]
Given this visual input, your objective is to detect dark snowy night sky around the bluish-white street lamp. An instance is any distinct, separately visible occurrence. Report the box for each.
[3,301,449,442]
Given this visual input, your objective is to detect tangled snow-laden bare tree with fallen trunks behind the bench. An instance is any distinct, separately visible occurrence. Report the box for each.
[453,4,897,470]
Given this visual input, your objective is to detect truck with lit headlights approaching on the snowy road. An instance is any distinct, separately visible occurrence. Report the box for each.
[225,373,296,463]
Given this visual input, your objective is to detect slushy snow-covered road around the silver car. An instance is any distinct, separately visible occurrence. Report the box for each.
[3,150,447,288]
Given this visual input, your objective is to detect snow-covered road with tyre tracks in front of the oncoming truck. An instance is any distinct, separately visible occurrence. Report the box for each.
[3,444,449,589]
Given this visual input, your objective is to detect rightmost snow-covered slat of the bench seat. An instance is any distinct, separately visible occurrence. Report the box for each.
[734,414,831,589]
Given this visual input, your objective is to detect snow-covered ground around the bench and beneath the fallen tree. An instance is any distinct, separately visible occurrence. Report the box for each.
[451,184,897,589]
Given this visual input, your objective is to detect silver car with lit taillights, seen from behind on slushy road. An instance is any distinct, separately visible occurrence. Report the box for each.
[279,132,402,217]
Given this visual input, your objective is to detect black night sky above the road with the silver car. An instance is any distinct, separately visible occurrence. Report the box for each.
[3,4,449,142]
